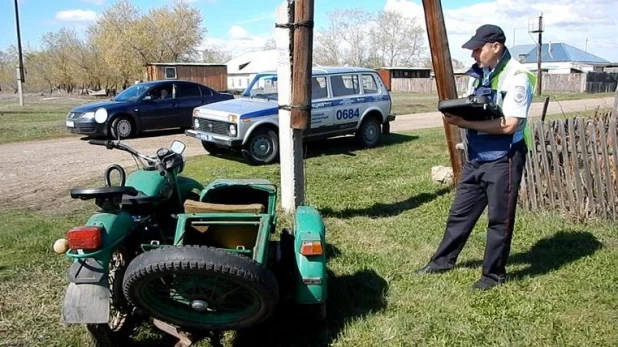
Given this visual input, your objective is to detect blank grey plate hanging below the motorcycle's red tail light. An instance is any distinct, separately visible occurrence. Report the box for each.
[62,282,110,324]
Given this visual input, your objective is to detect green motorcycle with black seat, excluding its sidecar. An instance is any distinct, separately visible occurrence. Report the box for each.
[54,140,203,346]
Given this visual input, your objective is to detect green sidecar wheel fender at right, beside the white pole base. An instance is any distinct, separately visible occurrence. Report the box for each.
[294,206,327,304]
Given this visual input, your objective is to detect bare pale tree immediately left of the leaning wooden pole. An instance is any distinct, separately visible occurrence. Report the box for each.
[370,11,427,67]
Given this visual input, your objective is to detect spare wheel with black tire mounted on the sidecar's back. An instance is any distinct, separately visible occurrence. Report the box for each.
[124,247,279,330]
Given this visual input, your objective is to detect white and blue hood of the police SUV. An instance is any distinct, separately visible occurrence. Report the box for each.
[196,98,277,120]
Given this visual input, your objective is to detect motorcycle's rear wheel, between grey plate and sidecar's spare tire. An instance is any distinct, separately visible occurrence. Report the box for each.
[86,247,135,347]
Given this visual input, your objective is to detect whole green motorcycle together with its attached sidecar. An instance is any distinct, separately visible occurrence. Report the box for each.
[56,141,328,345]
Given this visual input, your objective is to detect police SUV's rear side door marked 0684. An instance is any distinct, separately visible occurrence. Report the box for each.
[330,74,364,130]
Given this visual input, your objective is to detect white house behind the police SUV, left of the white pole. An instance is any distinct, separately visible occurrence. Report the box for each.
[225,49,279,91]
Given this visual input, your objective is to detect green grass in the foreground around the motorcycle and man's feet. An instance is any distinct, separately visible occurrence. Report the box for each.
[0,129,618,346]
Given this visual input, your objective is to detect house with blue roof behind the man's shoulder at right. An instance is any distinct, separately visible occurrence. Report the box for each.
[509,42,610,74]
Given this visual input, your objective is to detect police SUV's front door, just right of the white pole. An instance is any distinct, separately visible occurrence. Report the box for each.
[309,76,333,134]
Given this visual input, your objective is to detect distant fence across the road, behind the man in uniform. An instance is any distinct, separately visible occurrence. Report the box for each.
[391,72,618,95]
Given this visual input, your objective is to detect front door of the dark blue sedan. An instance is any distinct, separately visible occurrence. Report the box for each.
[139,83,177,130]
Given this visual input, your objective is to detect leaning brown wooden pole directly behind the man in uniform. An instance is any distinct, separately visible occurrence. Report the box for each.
[423,0,463,184]
